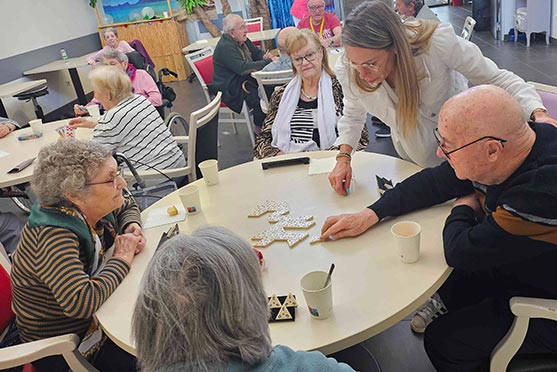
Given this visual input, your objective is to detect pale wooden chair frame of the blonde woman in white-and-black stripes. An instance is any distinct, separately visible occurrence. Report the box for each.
[124,92,222,182]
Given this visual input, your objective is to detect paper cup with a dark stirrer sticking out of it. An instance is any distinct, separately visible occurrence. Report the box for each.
[300,271,333,319]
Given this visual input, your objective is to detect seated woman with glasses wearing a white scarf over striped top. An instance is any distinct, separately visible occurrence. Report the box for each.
[253,30,369,159]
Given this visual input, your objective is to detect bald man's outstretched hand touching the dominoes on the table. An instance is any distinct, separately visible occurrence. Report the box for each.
[321,208,379,240]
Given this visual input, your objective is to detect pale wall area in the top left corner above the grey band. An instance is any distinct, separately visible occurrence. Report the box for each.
[0,0,97,59]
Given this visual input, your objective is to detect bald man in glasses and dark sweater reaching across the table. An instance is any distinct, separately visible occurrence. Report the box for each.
[322,85,557,372]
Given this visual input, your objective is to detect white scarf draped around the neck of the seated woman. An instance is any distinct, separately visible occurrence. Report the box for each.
[271,70,339,154]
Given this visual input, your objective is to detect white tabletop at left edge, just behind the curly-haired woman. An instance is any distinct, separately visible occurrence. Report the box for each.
[0,119,92,187]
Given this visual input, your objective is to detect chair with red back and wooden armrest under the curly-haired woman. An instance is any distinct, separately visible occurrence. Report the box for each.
[0,244,98,372]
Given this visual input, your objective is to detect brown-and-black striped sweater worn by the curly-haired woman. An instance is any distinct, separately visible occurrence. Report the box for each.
[11,201,140,342]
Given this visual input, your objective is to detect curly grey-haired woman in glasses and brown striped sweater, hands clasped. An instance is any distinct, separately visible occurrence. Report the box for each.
[11,140,145,372]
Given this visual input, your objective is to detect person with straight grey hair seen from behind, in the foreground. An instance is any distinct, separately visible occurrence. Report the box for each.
[132,226,353,372]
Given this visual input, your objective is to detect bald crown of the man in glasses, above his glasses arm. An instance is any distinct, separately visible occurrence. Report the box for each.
[439,85,528,139]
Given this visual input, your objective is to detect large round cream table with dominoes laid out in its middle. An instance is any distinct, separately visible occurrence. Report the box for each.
[96,152,451,354]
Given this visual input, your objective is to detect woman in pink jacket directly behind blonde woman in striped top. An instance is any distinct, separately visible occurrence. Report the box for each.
[73,49,162,116]
